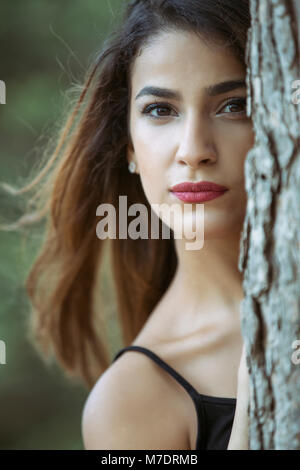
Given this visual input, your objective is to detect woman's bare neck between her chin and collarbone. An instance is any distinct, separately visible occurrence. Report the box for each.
[172,230,243,313]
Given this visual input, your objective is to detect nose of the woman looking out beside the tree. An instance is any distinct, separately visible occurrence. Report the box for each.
[176,114,217,168]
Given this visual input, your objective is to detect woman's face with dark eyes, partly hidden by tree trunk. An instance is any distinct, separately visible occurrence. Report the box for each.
[127,31,254,238]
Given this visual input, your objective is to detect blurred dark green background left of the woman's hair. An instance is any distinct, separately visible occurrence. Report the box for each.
[0,0,124,449]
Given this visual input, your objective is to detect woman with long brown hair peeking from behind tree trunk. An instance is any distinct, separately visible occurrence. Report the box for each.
[5,0,254,450]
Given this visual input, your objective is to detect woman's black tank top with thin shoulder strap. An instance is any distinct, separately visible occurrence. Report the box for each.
[112,346,236,450]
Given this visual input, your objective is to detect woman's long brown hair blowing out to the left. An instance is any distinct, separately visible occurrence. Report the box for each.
[0,0,250,387]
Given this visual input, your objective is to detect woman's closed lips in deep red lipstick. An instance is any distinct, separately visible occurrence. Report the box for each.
[170,181,228,202]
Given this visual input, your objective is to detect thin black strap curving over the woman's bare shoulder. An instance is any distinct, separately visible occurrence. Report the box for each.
[112,346,206,449]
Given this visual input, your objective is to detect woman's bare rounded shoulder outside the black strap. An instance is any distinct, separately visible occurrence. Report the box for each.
[82,351,190,450]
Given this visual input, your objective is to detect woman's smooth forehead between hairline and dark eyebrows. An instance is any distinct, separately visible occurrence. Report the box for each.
[131,31,245,91]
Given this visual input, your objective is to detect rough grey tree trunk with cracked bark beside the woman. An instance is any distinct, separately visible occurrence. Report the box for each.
[239,0,300,449]
